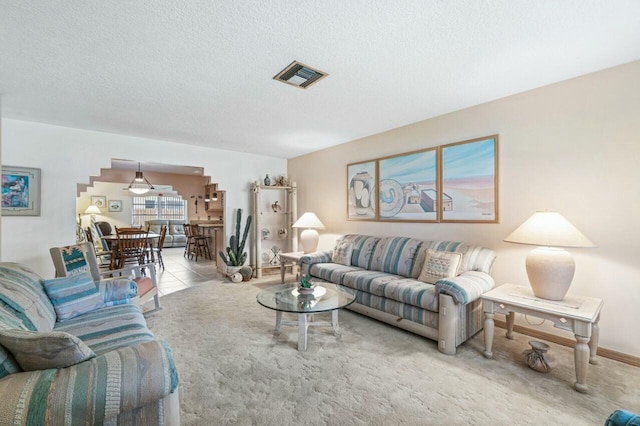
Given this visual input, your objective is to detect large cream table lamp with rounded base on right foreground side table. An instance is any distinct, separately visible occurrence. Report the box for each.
[504,211,595,300]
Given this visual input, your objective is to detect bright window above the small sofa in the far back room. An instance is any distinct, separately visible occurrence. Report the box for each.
[131,195,187,226]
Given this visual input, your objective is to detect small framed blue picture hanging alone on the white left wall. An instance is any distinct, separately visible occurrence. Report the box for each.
[2,166,40,216]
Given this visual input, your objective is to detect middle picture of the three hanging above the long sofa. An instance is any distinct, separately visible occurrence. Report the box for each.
[378,148,438,222]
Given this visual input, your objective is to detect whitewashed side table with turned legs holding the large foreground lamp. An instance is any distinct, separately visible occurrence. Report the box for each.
[482,284,603,392]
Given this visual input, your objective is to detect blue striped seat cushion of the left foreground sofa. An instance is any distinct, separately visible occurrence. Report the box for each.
[55,305,154,355]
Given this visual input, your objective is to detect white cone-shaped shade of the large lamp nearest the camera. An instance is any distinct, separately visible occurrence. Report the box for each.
[504,211,595,247]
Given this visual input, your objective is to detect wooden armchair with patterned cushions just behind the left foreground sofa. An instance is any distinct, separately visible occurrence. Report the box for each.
[49,242,160,314]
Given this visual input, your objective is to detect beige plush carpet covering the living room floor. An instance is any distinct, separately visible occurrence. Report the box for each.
[148,280,640,425]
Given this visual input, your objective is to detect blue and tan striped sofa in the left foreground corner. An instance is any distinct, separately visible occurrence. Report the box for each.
[0,263,180,425]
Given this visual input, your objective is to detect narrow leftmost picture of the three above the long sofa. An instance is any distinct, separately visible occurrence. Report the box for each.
[347,160,378,220]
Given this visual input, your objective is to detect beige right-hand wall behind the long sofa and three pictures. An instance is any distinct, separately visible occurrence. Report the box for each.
[288,62,640,356]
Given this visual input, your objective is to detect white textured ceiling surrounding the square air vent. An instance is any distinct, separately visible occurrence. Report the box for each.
[0,0,640,158]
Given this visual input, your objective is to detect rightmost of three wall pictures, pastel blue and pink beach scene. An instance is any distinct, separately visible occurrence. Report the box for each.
[439,135,499,223]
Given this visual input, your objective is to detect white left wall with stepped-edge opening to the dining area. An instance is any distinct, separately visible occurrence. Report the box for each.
[0,119,287,277]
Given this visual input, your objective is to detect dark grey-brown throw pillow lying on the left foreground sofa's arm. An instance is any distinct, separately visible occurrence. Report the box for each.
[0,330,96,371]
